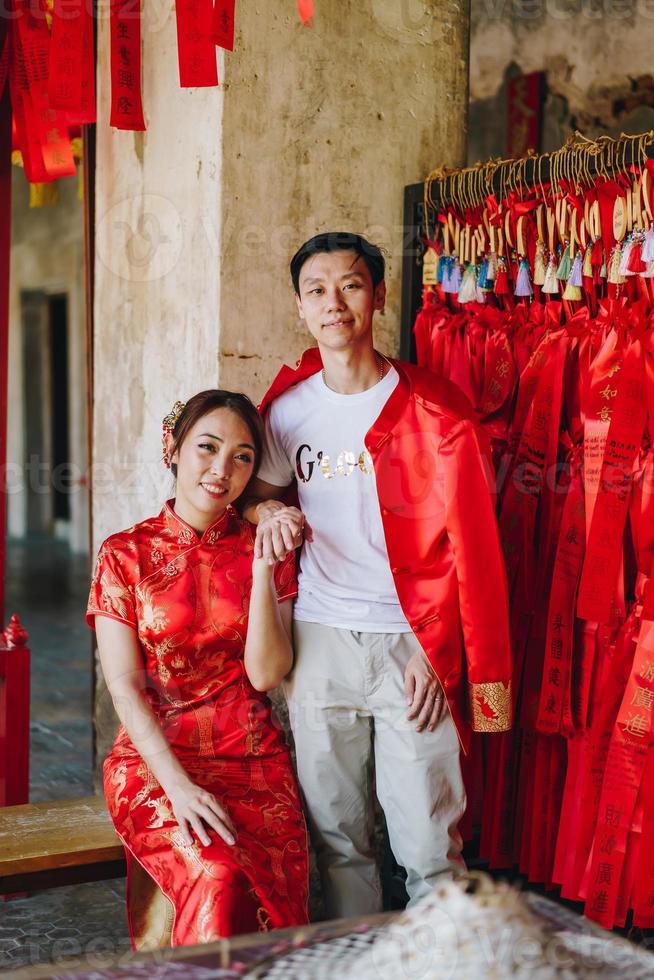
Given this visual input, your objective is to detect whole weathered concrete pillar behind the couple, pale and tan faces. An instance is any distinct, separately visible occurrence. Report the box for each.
[93,0,469,757]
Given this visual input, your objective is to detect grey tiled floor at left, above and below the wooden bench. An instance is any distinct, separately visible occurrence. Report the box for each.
[0,540,129,976]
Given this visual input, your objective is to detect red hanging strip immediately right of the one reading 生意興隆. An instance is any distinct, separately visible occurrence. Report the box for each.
[175,0,218,88]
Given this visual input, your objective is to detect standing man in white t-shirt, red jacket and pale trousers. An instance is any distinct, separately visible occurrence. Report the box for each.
[245,233,511,917]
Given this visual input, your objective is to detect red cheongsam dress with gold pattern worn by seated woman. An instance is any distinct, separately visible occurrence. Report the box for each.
[87,502,308,949]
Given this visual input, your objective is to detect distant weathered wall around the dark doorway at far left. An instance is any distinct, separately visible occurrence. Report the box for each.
[7,167,88,552]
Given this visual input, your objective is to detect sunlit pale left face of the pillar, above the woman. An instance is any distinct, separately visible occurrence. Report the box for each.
[92,4,223,759]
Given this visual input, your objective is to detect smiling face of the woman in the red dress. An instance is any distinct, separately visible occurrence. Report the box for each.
[172,408,255,531]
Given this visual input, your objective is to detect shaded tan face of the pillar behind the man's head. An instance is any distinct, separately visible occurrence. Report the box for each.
[220,0,468,397]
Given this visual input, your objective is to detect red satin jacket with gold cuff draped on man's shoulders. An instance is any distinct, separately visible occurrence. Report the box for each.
[261,348,511,748]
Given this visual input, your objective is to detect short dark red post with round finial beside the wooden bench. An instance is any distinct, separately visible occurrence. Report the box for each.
[0,615,30,806]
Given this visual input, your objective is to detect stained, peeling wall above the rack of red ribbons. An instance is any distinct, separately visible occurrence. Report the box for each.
[468,0,654,163]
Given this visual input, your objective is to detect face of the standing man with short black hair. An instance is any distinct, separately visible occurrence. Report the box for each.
[296,251,386,350]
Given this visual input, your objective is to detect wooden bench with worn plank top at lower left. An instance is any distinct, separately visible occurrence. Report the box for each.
[0,796,125,895]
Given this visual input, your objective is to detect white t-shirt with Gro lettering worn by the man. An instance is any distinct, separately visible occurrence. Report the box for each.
[258,367,411,633]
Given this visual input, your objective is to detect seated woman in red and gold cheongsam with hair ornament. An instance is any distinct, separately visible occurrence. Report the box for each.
[87,390,308,949]
